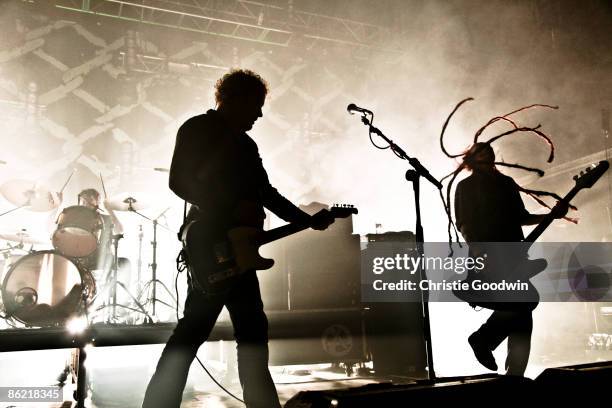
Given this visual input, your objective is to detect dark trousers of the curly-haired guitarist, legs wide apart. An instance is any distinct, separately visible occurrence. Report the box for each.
[142,271,281,408]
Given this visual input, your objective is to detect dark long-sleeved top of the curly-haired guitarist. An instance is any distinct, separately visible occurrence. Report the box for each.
[170,110,308,234]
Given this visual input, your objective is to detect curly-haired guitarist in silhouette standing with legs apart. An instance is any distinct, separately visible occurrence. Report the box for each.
[143,70,332,408]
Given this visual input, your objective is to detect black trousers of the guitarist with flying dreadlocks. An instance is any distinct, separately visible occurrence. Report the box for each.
[476,308,533,376]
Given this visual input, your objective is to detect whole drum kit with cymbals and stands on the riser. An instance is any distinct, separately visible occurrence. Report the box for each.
[0,180,172,327]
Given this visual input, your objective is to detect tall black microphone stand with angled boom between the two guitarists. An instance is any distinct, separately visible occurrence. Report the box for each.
[354,112,442,381]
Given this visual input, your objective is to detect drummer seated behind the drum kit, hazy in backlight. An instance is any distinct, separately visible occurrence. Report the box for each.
[78,188,123,270]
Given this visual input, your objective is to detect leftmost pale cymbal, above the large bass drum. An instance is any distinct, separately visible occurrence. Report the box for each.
[0,180,60,212]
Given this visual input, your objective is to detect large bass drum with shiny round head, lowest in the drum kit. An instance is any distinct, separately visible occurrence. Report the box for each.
[2,251,96,327]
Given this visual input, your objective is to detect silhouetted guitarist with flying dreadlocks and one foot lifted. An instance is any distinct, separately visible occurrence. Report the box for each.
[455,143,567,376]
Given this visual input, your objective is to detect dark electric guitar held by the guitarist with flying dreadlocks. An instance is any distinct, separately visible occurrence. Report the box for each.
[454,160,610,307]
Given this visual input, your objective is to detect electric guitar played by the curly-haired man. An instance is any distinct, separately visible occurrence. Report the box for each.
[181,205,358,294]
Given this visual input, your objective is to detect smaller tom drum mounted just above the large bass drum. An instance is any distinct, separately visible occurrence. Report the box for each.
[52,205,103,258]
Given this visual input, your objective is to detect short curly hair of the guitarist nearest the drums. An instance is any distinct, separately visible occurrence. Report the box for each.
[215,69,268,105]
